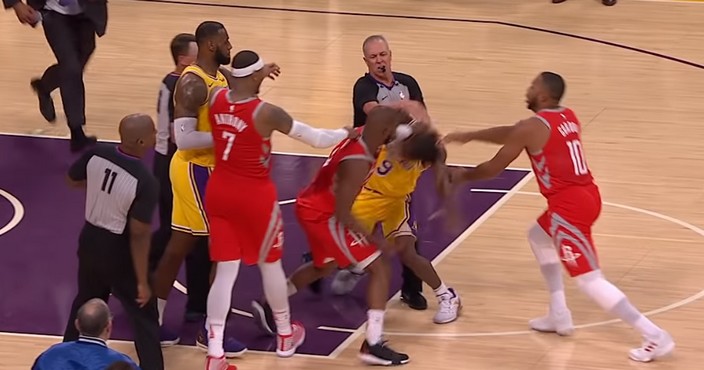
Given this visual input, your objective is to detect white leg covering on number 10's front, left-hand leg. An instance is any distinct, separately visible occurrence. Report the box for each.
[528,223,567,314]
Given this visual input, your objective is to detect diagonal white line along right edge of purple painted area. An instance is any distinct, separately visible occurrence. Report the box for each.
[328,172,533,358]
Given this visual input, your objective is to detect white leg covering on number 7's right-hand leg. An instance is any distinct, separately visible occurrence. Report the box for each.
[259,260,295,335]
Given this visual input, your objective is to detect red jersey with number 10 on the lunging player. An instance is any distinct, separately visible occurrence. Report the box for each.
[528,107,594,198]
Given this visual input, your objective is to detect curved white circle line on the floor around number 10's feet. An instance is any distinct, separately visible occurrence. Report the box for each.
[318,187,704,338]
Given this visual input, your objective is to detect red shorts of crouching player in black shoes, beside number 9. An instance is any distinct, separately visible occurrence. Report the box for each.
[296,205,381,270]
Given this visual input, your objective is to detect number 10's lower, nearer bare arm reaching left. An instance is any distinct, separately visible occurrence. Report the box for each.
[452,118,544,182]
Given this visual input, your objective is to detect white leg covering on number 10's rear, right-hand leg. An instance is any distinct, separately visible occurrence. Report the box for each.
[577,270,662,338]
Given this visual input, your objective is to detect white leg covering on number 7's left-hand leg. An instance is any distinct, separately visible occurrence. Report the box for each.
[205,260,240,358]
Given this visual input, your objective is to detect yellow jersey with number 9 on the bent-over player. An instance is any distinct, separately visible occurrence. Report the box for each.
[362,146,426,197]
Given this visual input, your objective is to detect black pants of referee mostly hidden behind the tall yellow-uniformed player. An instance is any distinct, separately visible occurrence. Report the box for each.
[149,144,211,314]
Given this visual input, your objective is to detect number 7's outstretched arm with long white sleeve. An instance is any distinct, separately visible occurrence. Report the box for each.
[255,103,356,148]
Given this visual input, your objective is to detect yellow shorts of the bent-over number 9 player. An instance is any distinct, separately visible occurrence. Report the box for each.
[352,189,416,240]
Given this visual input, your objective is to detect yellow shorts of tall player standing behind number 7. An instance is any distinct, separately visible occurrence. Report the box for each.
[169,155,213,236]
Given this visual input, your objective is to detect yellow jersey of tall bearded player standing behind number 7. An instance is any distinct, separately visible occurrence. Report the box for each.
[174,65,228,167]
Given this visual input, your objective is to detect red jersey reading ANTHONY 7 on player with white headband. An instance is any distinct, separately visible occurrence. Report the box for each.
[209,89,271,179]
